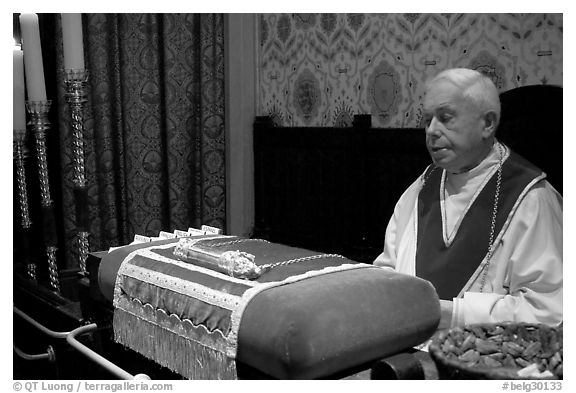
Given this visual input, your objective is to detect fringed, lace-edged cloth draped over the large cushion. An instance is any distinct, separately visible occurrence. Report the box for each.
[113,236,378,379]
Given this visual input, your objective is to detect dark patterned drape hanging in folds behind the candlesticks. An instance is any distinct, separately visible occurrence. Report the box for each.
[56,14,225,267]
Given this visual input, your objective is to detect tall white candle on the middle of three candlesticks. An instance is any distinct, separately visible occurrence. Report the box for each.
[20,14,46,101]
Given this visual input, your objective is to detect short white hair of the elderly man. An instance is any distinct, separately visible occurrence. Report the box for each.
[426,68,500,124]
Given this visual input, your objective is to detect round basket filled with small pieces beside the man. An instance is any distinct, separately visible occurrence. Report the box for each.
[429,323,563,379]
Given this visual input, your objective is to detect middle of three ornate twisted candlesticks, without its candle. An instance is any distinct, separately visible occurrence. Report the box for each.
[26,100,60,293]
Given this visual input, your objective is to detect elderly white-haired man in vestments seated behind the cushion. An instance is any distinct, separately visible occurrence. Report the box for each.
[374,69,562,328]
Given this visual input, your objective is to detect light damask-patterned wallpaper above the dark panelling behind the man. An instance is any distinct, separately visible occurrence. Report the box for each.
[257,14,563,127]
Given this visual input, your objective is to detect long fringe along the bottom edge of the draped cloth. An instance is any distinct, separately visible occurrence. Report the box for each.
[113,309,238,380]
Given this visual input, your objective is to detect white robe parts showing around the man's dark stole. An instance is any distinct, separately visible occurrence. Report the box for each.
[374,142,563,326]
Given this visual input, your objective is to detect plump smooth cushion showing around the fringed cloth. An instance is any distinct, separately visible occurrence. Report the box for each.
[99,240,440,379]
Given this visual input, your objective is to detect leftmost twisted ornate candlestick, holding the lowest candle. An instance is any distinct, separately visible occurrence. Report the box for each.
[14,129,37,281]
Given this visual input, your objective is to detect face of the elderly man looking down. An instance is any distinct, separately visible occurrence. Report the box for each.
[424,80,485,173]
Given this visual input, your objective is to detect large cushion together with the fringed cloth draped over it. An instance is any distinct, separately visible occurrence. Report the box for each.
[98,235,440,379]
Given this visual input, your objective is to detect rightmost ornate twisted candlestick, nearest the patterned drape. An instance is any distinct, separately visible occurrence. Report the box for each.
[64,69,90,274]
